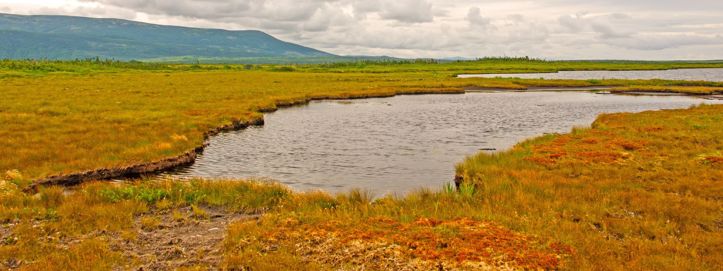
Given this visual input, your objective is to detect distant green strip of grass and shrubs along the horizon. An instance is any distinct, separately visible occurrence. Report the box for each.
[0,57,723,75]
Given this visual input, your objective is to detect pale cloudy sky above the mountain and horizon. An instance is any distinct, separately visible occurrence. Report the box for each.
[0,0,723,60]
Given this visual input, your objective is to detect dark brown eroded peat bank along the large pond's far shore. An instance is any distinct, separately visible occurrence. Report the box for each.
[25,86,714,192]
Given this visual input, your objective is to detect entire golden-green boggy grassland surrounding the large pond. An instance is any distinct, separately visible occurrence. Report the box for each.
[0,59,723,270]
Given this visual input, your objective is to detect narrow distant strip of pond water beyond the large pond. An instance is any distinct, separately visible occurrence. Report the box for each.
[458,69,723,81]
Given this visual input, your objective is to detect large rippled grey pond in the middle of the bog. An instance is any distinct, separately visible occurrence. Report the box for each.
[169,92,723,196]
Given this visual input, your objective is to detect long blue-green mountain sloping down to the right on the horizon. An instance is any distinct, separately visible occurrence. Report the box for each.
[0,13,336,60]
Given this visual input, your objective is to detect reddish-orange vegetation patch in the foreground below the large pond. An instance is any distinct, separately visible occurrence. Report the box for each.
[266,217,573,269]
